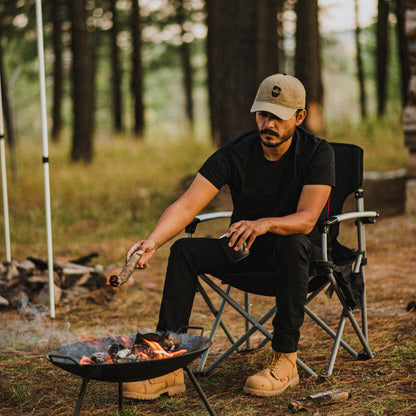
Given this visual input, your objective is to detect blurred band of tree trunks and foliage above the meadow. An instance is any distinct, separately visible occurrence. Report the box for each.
[0,0,409,157]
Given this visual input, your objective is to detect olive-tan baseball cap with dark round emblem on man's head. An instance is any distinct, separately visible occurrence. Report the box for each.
[250,74,306,120]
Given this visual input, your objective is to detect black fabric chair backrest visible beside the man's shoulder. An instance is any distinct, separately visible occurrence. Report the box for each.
[329,143,363,216]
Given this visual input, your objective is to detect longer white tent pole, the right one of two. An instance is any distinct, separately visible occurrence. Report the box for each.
[36,0,55,318]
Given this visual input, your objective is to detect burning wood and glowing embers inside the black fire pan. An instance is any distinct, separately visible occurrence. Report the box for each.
[79,333,187,365]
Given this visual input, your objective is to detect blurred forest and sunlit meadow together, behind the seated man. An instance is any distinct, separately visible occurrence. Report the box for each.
[0,0,409,261]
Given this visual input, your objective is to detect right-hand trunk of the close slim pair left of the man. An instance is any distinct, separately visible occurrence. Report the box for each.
[131,0,144,138]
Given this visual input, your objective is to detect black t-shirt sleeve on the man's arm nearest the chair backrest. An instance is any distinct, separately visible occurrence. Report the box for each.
[303,141,335,187]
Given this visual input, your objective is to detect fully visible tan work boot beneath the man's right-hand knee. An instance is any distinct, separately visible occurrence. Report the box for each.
[243,351,299,396]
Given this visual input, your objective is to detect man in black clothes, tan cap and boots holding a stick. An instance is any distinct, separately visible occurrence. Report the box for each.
[124,74,335,399]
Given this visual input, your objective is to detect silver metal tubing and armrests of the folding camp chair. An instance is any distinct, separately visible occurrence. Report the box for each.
[186,189,378,377]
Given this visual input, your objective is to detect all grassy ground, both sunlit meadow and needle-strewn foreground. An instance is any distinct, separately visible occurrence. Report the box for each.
[0,121,416,416]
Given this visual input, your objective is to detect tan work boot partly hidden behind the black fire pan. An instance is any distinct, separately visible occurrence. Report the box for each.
[123,368,186,400]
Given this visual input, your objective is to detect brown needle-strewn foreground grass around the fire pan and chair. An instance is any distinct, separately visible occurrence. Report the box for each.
[0,234,416,416]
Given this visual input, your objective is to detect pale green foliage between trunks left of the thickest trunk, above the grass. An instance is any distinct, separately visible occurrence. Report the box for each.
[0,0,207,139]
